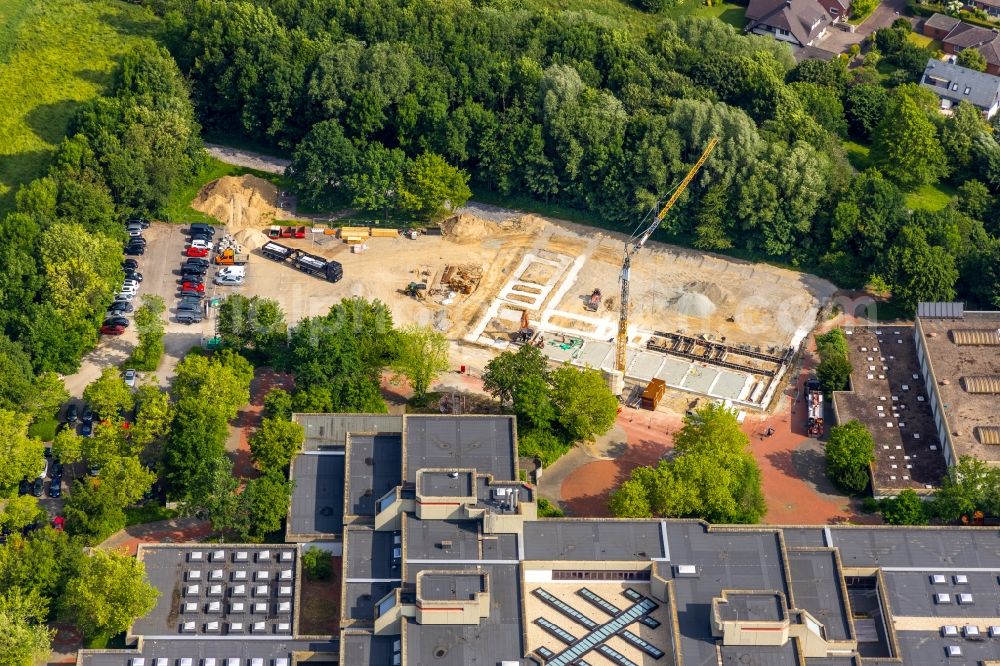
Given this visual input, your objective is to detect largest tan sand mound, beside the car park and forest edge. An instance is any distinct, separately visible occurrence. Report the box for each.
[191,175,280,231]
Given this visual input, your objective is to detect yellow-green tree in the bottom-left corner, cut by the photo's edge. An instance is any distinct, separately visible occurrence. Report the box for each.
[0,589,56,666]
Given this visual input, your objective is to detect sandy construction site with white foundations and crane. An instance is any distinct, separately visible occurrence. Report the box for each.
[192,176,835,410]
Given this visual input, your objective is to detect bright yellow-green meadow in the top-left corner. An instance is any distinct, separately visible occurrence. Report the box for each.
[0,0,157,214]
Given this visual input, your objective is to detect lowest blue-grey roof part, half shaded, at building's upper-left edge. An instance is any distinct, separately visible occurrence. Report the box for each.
[288,454,344,535]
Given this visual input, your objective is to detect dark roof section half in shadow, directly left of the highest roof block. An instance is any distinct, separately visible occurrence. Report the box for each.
[347,435,403,516]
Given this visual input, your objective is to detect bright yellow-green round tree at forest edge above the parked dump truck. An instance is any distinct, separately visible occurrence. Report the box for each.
[396,153,472,220]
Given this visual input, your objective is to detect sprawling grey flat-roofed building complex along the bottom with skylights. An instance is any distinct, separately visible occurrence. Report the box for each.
[78,415,1000,666]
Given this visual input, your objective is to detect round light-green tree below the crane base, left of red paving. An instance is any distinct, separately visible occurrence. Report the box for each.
[552,366,618,441]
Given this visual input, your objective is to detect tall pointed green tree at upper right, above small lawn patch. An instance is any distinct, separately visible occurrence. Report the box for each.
[870,94,948,189]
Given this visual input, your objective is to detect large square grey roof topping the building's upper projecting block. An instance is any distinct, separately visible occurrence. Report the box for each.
[406,416,517,481]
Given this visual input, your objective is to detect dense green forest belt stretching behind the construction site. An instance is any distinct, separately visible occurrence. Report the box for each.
[150,0,1000,313]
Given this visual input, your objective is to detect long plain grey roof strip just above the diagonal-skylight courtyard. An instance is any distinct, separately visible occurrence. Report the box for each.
[524,520,663,560]
